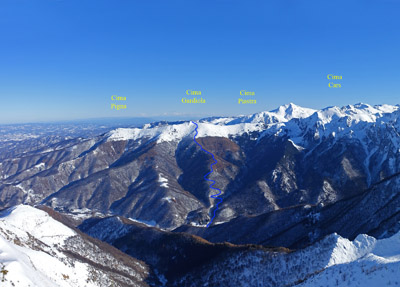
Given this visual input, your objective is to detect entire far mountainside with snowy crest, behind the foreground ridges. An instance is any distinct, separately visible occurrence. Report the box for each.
[0,104,400,247]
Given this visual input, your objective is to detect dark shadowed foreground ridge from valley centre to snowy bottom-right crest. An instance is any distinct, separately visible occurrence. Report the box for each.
[80,217,400,287]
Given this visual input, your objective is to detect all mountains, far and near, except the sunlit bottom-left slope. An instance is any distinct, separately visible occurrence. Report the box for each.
[0,104,400,286]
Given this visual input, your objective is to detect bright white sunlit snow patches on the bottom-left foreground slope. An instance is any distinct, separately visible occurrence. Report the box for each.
[0,205,81,286]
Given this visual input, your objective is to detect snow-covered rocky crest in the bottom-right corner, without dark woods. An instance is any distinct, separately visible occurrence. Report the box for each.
[299,233,400,287]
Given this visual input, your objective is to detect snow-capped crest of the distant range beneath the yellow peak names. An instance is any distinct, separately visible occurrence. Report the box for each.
[106,103,400,145]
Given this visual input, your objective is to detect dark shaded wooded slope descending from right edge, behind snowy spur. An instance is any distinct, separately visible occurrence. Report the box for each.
[175,174,400,248]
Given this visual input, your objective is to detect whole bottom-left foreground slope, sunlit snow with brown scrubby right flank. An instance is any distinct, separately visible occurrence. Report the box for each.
[0,205,147,287]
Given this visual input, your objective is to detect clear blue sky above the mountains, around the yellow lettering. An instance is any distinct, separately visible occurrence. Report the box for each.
[0,0,400,123]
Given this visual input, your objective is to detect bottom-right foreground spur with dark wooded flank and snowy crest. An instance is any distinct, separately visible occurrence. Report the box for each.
[175,233,400,287]
